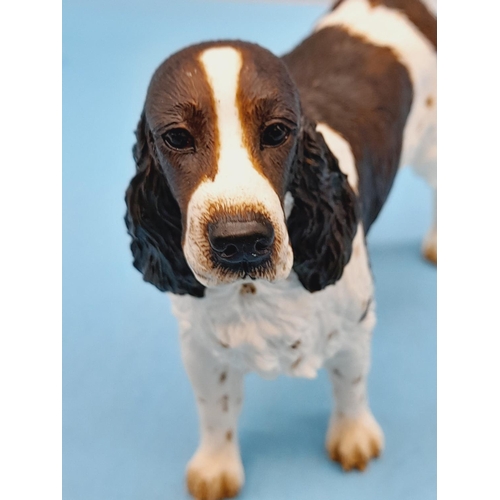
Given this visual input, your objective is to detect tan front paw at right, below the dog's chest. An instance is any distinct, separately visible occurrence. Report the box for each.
[326,411,384,471]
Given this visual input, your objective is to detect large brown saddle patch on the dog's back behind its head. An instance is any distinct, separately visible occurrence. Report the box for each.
[283,26,413,232]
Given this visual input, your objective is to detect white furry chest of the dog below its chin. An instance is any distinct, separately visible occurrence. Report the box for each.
[171,227,375,378]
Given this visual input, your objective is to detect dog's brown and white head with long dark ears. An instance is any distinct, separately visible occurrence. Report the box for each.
[126,42,357,296]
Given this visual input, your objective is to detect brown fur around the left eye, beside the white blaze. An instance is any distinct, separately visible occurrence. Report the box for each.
[144,43,219,220]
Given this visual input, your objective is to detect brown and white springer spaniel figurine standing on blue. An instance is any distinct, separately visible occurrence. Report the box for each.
[126,0,437,500]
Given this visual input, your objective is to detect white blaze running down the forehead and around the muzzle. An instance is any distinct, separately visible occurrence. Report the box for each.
[183,47,293,286]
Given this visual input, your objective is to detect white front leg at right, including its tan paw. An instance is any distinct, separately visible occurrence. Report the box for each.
[326,331,384,471]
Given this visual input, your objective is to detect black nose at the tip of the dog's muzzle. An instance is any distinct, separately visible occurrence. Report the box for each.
[208,221,274,264]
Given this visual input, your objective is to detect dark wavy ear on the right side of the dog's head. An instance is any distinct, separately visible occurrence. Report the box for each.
[287,119,359,292]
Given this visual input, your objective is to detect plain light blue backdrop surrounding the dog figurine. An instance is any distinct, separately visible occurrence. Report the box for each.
[62,0,436,500]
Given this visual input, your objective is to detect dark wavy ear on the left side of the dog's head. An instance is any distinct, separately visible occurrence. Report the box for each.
[125,112,205,297]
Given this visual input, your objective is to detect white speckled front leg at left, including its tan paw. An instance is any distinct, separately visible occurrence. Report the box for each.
[183,343,244,500]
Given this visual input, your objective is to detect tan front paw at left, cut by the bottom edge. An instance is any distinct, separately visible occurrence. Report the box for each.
[186,451,245,500]
